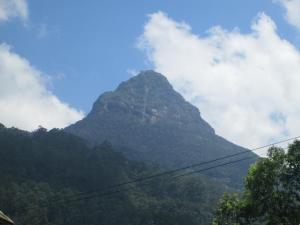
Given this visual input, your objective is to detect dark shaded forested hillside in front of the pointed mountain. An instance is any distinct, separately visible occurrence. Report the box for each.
[0,126,230,225]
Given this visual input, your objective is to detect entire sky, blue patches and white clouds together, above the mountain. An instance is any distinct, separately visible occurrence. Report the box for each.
[0,0,300,148]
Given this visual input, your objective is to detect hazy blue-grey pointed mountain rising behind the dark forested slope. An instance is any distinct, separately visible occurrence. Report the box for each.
[65,70,255,184]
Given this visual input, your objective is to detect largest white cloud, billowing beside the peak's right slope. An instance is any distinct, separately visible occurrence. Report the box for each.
[139,12,300,147]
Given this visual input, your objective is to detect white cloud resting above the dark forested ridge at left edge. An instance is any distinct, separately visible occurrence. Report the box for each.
[0,44,83,130]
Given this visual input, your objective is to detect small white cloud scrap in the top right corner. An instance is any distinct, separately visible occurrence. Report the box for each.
[277,0,300,29]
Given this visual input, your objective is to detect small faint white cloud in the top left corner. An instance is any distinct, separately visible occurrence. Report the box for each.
[0,0,28,22]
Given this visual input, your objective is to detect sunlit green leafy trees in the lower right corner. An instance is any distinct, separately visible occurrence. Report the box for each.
[214,141,300,225]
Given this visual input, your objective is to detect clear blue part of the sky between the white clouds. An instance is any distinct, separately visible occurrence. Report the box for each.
[0,0,299,112]
